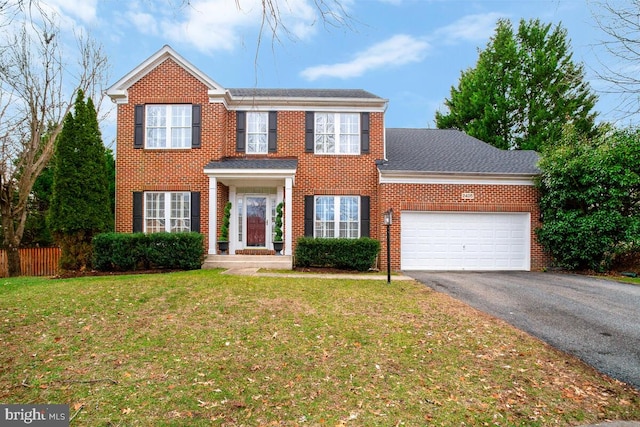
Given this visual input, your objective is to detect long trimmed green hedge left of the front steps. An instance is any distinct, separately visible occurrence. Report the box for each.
[93,233,204,271]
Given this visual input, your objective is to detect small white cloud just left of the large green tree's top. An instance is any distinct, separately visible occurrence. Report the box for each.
[432,12,506,44]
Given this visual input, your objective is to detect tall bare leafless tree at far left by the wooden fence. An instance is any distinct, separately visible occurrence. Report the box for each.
[0,9,107,276]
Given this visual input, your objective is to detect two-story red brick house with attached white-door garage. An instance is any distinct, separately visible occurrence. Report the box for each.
[107,46,545,270]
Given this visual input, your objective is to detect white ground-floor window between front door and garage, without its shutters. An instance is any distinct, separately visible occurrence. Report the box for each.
[314,196,360,239]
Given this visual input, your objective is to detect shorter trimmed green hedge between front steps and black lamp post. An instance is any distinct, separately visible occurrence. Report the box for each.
[295,237,380,271]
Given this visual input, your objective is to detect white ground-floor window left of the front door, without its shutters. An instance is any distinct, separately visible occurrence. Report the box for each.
[144,192,191,233]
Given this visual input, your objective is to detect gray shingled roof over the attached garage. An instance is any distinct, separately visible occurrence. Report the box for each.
[378,128,540,175]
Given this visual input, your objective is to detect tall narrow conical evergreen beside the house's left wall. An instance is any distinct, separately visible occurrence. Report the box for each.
[49,90,112,270]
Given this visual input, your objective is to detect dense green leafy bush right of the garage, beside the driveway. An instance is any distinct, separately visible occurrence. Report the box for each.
[537,128,640,270]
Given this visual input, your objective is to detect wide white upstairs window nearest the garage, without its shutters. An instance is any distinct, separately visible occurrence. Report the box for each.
[315,113,360,154]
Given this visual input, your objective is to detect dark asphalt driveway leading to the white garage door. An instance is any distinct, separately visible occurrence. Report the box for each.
[404,271,640,389]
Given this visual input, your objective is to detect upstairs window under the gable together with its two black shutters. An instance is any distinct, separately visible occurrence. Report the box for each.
[133,104,202,149]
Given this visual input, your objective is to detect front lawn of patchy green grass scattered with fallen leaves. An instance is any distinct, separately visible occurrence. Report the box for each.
[0,271,640,426]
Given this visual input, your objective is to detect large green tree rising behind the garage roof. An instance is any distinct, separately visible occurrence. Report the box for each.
[436,20,597,151]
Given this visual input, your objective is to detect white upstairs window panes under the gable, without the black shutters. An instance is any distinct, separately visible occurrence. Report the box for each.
[145,104,192,149]
